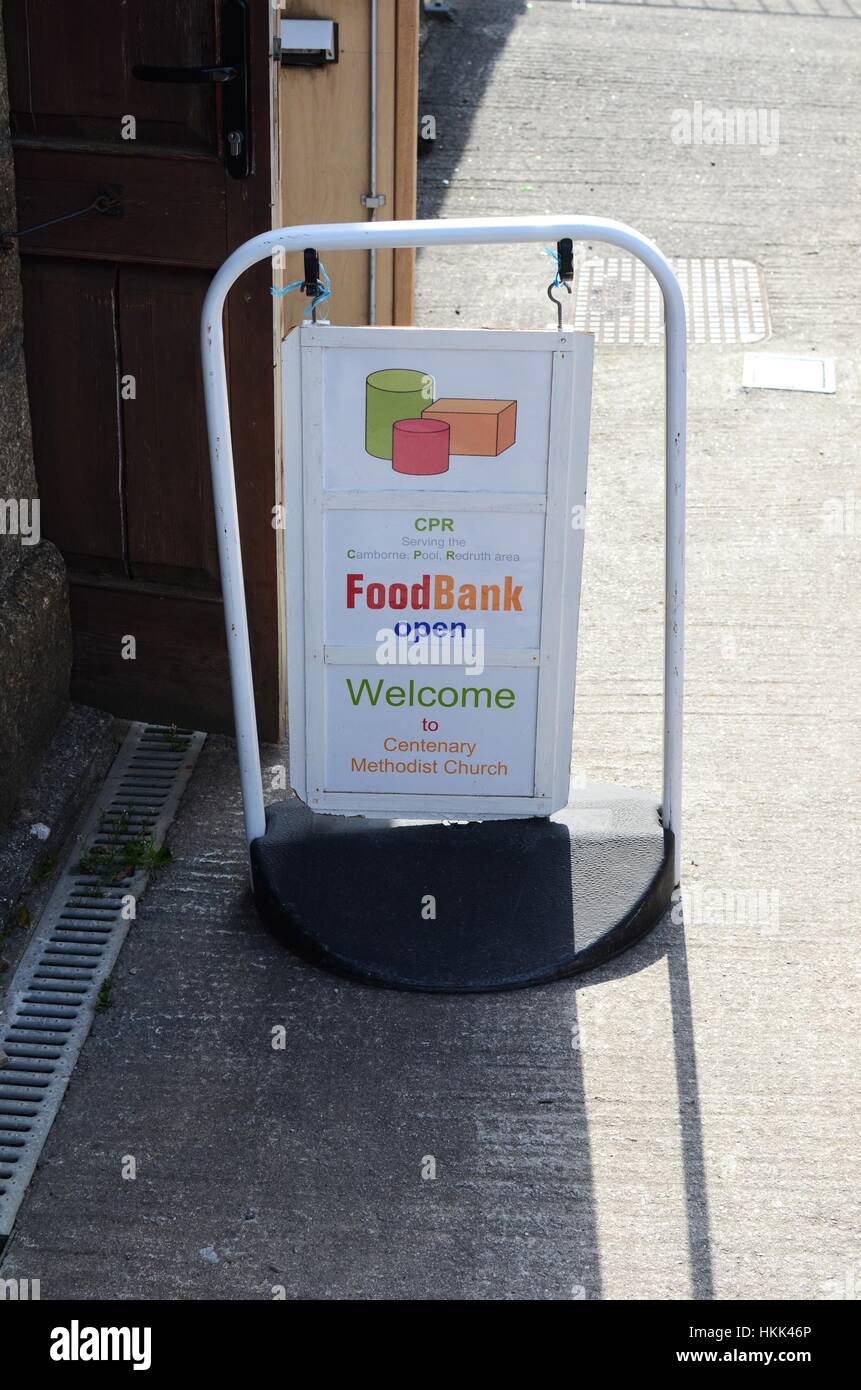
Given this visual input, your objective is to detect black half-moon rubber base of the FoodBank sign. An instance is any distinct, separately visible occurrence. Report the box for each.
[250,787,673,992]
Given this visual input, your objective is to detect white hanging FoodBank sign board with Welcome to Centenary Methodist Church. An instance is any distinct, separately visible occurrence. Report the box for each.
[284,324,593,819]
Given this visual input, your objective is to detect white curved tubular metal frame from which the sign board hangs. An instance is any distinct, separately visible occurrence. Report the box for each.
[200,217,687,883]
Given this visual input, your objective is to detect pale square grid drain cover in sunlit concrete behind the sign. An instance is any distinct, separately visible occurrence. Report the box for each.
[563,256,771,346]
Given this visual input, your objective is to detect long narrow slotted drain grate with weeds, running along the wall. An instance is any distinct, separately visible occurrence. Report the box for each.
[0,724,206,1245]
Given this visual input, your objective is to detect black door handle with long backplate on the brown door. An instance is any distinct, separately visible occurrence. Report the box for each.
[132,0,252,178]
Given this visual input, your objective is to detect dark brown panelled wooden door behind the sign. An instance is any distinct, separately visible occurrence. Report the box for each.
[4,0,281,737]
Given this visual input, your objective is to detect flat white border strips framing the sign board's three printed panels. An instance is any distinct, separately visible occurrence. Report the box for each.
[282,324,593,819]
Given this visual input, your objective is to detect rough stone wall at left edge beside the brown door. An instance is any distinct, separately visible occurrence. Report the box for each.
[0,5,72,824]
